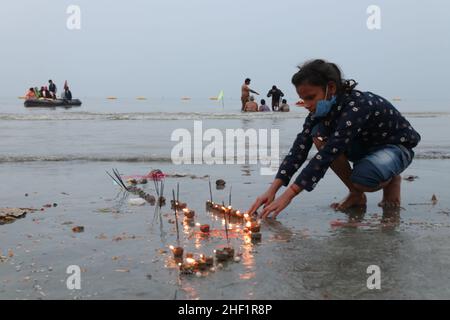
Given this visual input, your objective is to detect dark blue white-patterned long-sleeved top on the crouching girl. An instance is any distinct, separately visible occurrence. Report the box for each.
[276,90,420,191]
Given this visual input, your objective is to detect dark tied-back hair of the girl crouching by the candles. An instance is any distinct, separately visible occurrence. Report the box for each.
[292,59,358,94]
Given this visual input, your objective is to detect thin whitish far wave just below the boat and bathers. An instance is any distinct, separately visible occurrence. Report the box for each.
[0,112,450,121]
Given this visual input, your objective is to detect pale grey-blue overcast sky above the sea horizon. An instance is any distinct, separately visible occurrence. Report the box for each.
[0,0,450,99]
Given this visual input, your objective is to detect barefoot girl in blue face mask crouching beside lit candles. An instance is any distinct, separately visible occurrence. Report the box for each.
[249,60,421,218]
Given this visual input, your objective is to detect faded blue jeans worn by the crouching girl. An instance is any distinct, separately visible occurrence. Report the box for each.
[311,124,414,188]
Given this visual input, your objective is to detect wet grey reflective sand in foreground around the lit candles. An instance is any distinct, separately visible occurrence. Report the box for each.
[0,159,450,299]
